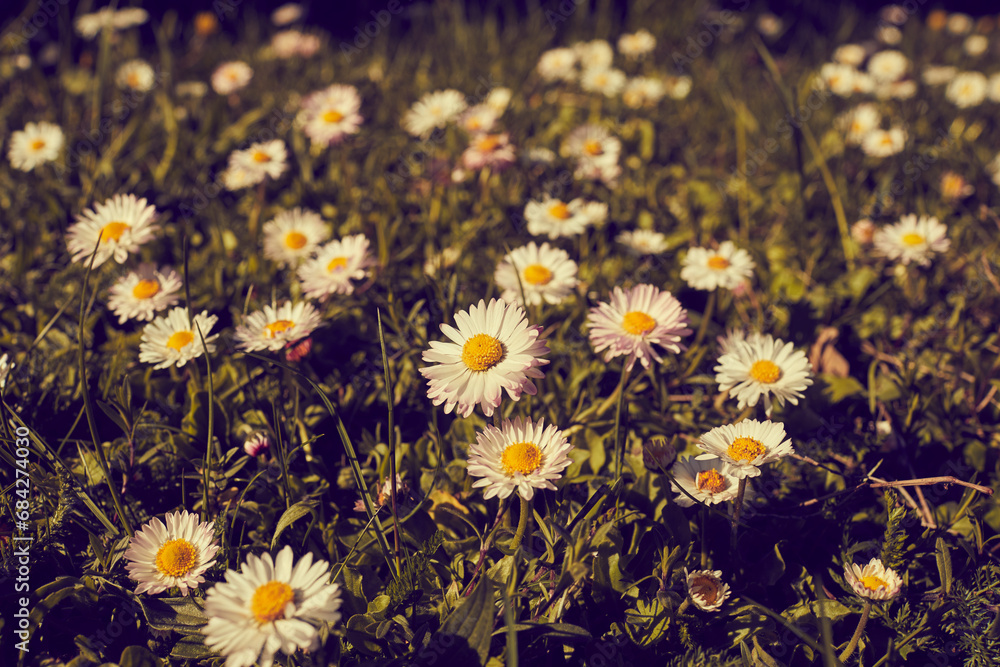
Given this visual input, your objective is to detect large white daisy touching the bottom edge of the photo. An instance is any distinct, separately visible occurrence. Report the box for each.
[202,546,343,667]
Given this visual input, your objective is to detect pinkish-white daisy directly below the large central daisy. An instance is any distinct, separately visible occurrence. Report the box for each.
[468,417,573,500]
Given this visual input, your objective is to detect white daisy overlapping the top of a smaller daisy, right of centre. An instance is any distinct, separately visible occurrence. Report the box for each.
[697,419,793,479]
